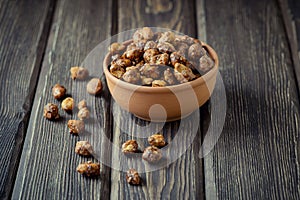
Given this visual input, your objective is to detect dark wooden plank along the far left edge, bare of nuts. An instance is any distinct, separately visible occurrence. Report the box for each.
[0,0,54,199]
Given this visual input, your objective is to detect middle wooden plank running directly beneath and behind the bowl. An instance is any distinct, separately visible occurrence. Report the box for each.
[111,0,204,199]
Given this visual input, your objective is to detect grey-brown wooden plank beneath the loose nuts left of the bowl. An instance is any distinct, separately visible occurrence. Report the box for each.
[12,0,112,199]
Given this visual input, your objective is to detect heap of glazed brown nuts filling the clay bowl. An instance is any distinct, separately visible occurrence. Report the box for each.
[109,27,214,87]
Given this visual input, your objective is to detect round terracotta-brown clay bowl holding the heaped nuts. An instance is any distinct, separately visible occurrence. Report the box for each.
[103,41,219,122]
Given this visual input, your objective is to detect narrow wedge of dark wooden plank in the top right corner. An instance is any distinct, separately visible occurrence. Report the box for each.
[278,0,300,92]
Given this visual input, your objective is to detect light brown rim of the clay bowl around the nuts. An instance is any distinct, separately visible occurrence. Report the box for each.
[103,39,219,93]
